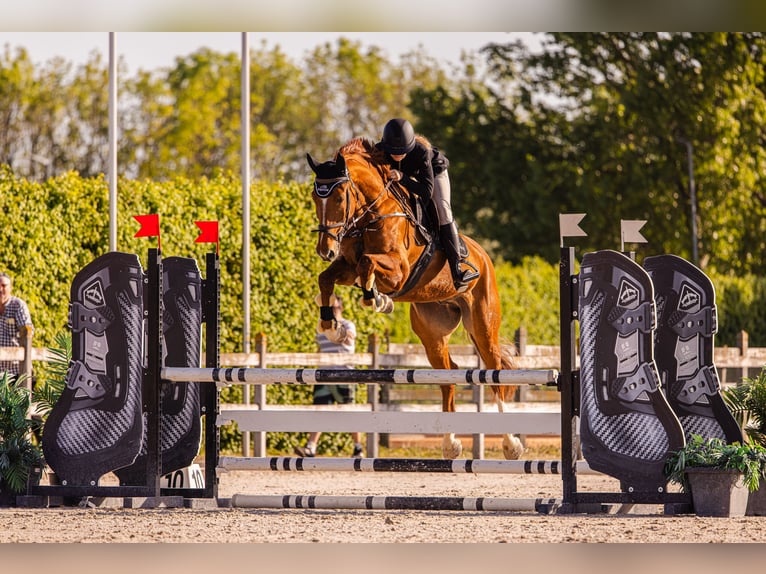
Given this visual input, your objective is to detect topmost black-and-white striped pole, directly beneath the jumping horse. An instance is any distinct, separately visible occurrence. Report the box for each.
[160,367,558,386]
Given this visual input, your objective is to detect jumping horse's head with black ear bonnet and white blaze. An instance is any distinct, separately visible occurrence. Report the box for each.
[306,153,351,261]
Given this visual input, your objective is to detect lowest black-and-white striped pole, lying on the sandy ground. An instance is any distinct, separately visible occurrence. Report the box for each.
[231,494,561,513]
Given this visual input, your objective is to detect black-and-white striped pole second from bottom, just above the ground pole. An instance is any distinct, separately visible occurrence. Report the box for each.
[218,456,599,474]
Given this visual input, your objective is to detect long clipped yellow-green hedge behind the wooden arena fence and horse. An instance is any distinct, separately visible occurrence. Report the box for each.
[0,167,766,454]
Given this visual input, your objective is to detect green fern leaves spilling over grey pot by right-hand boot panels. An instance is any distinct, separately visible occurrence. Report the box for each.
[664,434,766,492]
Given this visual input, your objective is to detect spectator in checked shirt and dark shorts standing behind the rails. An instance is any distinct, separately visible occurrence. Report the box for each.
[293,296,364,458]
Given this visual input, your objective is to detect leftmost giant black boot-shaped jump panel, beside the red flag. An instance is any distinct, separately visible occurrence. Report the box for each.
[43,251,144,486]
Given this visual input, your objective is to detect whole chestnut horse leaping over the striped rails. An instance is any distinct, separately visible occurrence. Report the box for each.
[306,138,523,459]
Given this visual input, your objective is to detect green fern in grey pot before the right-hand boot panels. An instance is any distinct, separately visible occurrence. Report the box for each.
[665,434,766,516]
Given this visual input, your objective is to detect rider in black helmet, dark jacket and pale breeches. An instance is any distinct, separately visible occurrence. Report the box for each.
[376,118,479,292]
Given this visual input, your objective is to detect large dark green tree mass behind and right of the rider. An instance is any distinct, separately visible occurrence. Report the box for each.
[410,32,766,275]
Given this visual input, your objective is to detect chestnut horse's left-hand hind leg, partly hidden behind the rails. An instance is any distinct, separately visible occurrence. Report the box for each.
[410,303,463,459]
